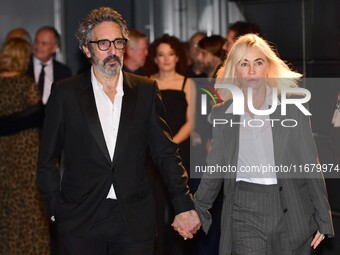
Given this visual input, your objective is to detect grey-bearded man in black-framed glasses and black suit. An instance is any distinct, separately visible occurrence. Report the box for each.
[38,7,200,255]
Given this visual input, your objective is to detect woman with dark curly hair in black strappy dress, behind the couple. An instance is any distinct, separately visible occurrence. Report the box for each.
[148,34,196,184]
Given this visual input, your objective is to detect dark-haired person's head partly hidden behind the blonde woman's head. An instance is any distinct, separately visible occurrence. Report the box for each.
[223,21,260,54]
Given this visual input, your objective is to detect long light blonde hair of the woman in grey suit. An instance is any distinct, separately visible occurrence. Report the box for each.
[217,34,302,101]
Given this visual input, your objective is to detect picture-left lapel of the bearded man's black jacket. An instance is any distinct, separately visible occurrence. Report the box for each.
[77,72,111,162]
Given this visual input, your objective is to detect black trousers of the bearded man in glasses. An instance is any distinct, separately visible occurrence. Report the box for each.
[61,199,153,255]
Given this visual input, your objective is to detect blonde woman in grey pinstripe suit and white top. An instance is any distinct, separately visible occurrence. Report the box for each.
[194,34,334,255]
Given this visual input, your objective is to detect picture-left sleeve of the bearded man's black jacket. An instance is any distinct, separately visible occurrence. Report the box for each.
[37,85,63,217]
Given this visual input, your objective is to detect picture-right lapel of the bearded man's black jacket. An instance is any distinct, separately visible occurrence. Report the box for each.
[113,72,137,163]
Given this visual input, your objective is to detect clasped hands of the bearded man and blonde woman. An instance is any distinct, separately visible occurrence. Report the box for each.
[171,210,201,240]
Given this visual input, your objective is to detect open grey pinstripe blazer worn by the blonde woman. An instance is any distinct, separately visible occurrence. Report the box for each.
[194,101,334,255]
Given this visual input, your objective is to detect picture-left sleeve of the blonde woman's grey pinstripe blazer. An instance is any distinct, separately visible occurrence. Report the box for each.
[194,105,225,233]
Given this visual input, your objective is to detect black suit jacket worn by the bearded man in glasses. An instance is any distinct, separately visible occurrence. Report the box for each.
[38,72,194,240]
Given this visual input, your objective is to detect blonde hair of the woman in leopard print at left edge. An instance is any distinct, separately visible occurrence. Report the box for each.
[0,38,31,74]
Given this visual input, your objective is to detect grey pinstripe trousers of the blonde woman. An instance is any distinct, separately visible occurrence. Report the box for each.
[232,181,312,255]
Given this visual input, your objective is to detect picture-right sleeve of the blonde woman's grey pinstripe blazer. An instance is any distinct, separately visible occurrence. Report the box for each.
[298,108,334,237]
